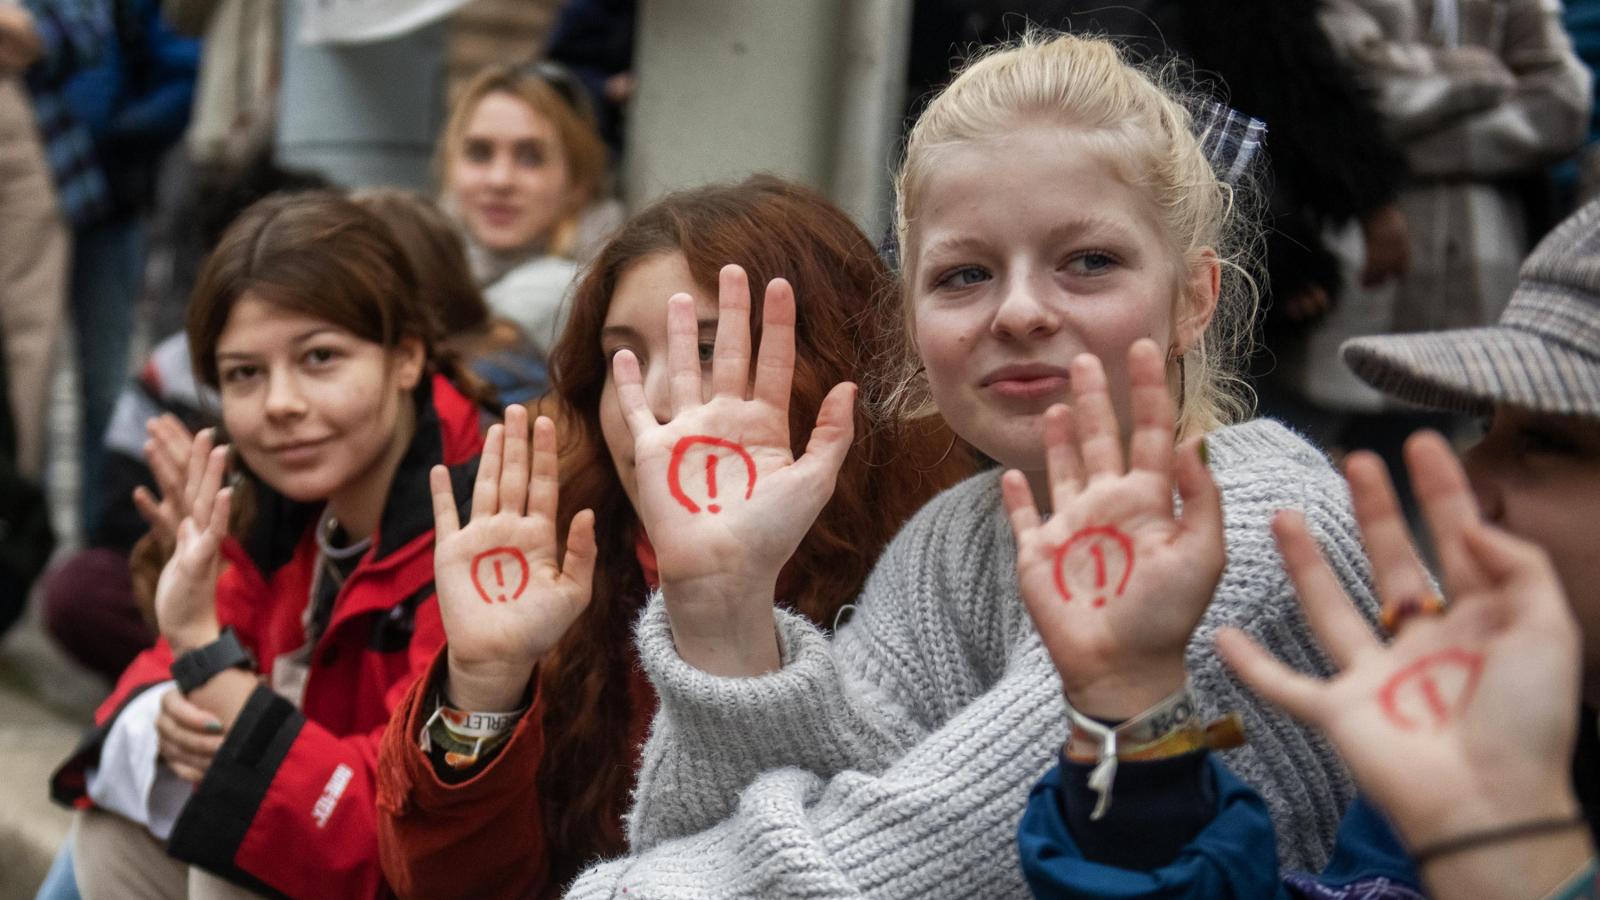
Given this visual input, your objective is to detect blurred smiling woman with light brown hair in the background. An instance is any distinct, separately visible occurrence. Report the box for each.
[438,66,617,359]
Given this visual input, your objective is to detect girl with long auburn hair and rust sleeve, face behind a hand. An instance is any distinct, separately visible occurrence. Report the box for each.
[379,178,971,897]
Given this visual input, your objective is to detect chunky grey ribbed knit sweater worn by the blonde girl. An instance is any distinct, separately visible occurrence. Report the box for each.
[568,420,1376,898]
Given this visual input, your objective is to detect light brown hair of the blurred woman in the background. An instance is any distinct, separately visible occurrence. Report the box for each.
[434,66,606,258]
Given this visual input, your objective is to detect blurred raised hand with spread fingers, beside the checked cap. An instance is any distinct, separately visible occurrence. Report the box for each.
[1218,434,1579,864]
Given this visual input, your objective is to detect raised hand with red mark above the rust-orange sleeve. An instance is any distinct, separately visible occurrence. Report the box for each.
[429,405,595,713]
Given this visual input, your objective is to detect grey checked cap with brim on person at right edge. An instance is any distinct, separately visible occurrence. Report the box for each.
[1339,200,1600,418]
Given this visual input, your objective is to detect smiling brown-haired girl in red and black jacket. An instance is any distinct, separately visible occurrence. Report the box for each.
[54,194,482,900]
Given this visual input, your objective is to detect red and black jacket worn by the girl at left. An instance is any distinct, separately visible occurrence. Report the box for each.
[51,376,483,897]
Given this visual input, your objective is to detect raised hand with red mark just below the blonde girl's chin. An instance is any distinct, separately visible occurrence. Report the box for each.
[1002,340,1224,719]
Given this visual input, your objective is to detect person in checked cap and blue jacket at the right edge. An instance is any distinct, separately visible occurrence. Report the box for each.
[1019,202,1600,898]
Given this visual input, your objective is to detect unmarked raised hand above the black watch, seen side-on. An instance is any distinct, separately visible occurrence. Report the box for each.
[155,442,234,657]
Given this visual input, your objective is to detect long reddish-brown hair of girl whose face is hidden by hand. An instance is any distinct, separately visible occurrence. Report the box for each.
[539,176,973,884]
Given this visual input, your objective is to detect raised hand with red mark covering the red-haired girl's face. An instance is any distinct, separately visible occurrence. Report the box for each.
[613,266,856,674]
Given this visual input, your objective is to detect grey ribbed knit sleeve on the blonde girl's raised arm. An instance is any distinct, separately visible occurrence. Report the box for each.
[611,479,1008,850]
